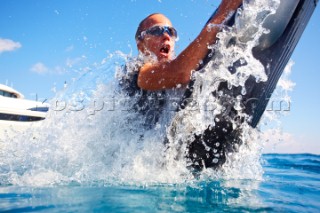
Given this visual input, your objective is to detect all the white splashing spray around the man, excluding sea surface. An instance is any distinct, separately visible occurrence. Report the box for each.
[0,0,288,186]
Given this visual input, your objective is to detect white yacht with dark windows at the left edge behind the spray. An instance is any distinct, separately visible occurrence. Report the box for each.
[0,84,49,139]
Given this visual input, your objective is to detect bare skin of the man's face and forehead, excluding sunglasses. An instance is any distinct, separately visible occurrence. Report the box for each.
[138,14,176,61]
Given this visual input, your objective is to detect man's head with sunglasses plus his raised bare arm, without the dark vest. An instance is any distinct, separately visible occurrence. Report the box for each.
[136,0,242,91]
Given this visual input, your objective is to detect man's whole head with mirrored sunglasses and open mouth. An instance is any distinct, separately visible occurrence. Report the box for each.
[136,13,177,60]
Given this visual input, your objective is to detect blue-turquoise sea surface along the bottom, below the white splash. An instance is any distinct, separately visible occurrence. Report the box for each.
[0,154,320,212]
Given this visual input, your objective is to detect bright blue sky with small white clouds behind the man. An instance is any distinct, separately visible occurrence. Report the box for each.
[0,0,320,153]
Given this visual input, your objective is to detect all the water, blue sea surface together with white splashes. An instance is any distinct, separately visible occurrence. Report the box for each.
[0,1,320,212]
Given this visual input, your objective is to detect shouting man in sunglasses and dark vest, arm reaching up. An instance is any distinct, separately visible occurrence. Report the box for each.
[120,0,242,129]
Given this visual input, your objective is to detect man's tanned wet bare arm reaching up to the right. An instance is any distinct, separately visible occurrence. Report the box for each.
[138,0,242,90]
